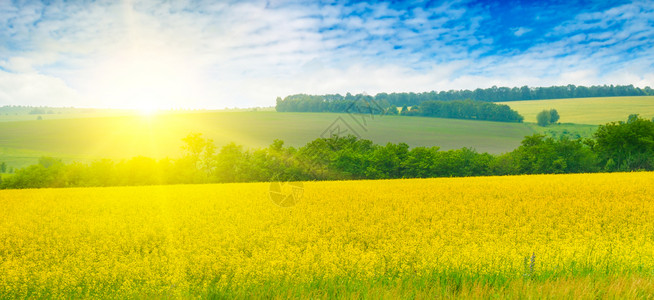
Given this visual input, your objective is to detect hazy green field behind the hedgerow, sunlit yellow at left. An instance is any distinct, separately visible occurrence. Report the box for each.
[0,111,536,167]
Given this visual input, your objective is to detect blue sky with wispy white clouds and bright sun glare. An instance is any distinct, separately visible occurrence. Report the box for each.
[0,0,654,109]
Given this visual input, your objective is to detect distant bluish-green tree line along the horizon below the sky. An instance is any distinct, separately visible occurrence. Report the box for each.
[277,84,654,112]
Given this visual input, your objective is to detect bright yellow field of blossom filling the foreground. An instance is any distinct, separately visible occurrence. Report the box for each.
[0,172,654,298]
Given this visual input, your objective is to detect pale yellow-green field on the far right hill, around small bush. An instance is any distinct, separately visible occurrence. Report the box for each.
[499,96,654,125]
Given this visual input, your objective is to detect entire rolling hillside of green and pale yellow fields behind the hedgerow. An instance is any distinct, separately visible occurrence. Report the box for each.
[7,96,654,168]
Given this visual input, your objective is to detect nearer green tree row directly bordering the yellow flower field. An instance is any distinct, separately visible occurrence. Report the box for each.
[0,115,654,189]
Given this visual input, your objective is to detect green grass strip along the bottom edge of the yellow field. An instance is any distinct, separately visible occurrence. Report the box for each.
[200,272,654,299]
